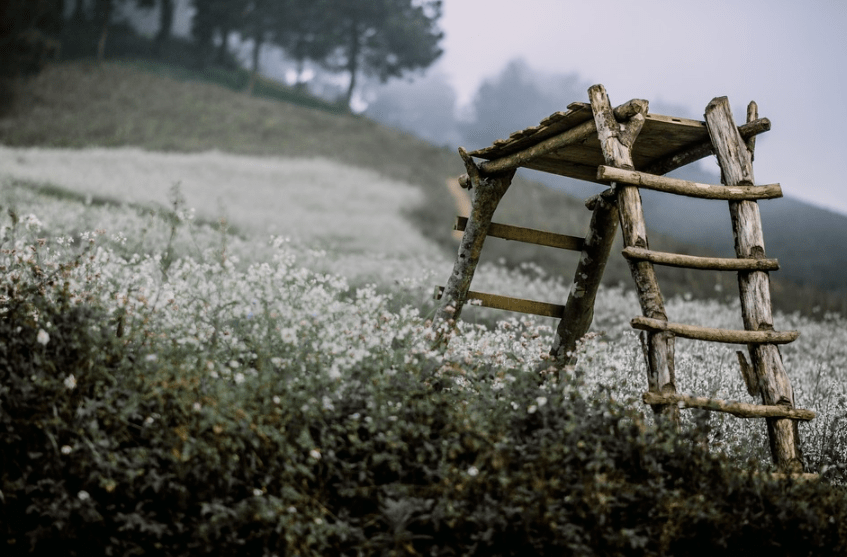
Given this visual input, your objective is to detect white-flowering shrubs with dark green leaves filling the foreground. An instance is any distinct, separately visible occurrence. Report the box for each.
[0,181,847,555]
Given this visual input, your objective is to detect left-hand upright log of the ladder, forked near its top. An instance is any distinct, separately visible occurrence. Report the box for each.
[588,85,679,423]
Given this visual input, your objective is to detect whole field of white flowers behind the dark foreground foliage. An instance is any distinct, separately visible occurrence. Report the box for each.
[0,148,847,472]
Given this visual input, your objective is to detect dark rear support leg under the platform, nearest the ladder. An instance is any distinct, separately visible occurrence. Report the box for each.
[550,192,618,367]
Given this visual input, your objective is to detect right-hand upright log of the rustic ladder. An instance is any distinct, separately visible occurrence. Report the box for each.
[705,97,803,472]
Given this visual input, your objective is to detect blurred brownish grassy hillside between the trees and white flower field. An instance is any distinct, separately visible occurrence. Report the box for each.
[0,62,841,310]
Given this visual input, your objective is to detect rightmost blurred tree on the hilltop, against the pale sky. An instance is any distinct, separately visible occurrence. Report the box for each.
[322,0,443,106]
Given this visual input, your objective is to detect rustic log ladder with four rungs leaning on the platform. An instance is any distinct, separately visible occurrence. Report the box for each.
[589,85,814,473]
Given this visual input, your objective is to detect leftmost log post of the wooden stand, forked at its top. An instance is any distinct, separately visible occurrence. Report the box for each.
[433,147,517,330]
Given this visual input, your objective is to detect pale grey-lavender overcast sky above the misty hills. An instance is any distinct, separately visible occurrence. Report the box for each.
[439,0,847,215]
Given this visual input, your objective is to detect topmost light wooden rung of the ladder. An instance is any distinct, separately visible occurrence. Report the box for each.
[597,165,782,201]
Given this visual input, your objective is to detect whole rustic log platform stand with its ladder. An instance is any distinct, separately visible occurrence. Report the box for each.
[433,85,814,473]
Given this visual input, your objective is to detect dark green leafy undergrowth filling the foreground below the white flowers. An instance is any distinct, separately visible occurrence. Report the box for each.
[0,270,847,555]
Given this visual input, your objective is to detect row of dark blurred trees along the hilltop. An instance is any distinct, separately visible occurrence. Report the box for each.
[0,0,443,106]
